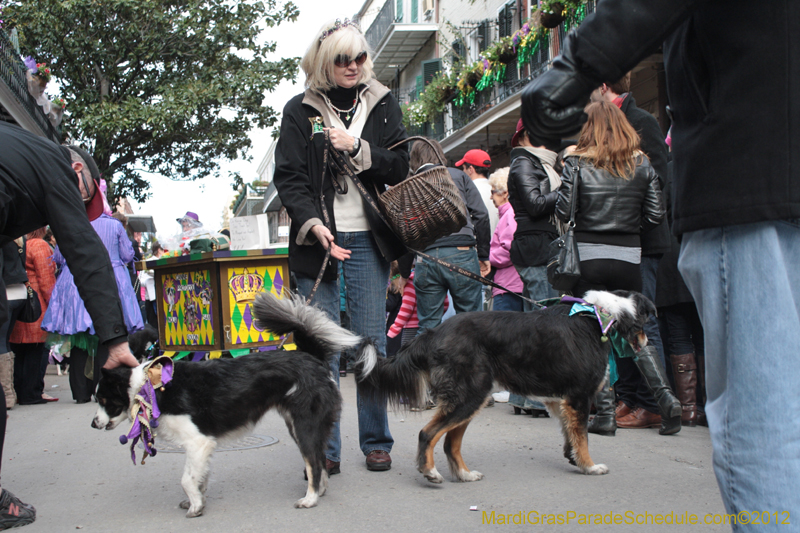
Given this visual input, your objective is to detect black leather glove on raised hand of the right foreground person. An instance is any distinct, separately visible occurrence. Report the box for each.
[522,31,602,142]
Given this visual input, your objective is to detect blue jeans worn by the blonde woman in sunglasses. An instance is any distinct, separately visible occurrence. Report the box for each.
[297,231,394,462]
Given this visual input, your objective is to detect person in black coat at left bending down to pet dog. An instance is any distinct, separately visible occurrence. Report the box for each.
[0,122,138,528]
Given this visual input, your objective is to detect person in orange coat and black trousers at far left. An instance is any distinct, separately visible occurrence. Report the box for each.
[11,228,58,405]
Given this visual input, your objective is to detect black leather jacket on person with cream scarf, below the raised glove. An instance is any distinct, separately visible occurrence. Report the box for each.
[508,148,558,235]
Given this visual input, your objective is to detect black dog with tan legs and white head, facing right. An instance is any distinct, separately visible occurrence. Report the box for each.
[355,291,655,483]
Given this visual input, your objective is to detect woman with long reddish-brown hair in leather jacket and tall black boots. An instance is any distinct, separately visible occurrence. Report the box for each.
[556,101,681,435]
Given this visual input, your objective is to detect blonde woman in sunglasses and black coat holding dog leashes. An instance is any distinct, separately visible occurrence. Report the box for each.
[274,19,408,474]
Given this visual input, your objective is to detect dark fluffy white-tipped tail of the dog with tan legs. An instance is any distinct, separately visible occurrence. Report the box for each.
[355,339,428,409]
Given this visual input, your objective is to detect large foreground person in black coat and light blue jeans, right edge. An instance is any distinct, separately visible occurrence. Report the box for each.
[522,0,800,516]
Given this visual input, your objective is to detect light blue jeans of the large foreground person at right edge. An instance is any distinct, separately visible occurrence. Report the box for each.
[678,219,800,531]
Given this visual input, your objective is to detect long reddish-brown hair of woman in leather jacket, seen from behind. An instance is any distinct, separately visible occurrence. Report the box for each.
[572,100,646,180]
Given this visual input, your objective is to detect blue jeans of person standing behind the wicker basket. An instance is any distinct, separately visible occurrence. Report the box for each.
[414,246,483,334]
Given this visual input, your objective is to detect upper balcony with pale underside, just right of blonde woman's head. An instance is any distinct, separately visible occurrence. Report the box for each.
[364,0,438,83]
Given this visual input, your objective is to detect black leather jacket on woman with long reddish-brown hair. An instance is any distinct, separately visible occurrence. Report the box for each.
[556,156,665,245]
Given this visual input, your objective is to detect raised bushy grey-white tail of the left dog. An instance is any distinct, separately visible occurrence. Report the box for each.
[253,291,361,360]
